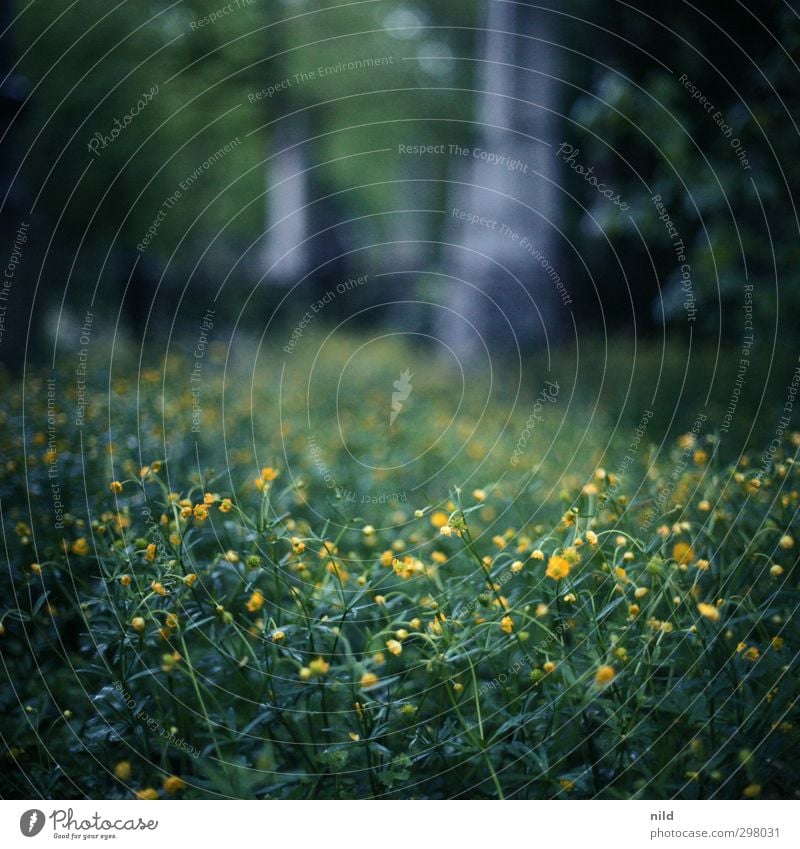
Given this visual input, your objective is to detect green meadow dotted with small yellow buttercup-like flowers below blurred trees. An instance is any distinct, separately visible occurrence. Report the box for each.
[0,339,800,799]
